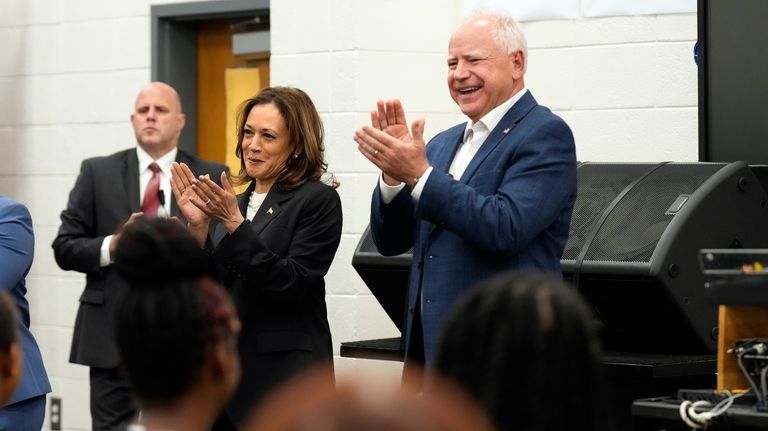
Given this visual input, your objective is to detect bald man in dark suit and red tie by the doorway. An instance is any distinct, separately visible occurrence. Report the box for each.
[53,82,227,431]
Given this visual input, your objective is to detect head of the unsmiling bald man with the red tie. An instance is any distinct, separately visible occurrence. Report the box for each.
[131,82,186,159]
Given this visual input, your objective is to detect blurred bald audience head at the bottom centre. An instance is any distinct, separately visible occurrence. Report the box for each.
[245,367,494,431]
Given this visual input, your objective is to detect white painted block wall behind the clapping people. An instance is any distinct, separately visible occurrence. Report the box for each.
[0,0,698,430]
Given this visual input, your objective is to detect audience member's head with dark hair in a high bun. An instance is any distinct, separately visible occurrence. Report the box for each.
[115,219,240,426]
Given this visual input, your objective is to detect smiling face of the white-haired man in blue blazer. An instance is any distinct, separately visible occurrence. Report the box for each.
[448,16,525,122]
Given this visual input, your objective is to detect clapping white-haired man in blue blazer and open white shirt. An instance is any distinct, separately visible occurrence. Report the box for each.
[354,14,576,366]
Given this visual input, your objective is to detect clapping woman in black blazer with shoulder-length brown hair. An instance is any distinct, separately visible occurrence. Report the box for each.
[172,87,342,429]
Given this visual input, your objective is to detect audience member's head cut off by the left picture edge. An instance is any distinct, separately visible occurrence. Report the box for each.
[0,291,22,407]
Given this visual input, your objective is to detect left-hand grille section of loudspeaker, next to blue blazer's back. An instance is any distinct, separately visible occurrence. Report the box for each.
[562,163,656,260]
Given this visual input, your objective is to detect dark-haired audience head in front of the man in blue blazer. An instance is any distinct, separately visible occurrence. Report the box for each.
[435,273,609,431]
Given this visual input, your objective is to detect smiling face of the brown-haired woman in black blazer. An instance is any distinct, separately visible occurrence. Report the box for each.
[242,103,292,193]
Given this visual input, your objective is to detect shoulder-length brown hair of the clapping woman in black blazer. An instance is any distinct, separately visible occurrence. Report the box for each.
[233,87,339,190]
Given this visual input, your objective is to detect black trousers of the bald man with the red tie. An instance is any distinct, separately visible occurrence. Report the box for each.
[90,367,137,431]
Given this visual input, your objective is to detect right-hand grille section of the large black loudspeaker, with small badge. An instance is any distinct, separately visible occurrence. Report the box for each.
[584,163,725,262]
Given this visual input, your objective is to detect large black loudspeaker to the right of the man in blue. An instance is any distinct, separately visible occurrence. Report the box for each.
[561,162,768,354]
